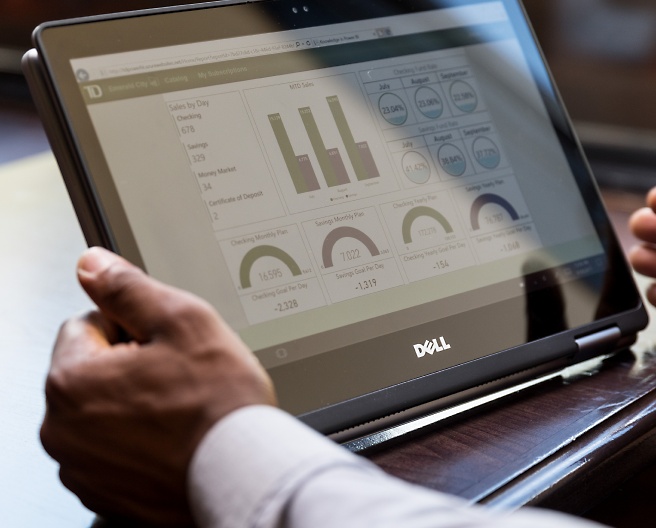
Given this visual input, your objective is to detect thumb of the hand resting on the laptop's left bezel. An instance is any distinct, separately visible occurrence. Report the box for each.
[78,248,218,343]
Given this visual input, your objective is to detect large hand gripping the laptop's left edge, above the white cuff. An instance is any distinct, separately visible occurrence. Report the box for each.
[41,248,275,526]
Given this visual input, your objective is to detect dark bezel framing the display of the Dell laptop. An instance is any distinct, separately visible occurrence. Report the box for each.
[30,0,644,432]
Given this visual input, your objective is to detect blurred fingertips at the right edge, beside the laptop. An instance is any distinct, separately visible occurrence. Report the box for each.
[629,187,656,305]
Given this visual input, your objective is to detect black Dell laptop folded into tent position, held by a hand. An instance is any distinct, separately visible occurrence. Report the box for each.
[24,0,647,441]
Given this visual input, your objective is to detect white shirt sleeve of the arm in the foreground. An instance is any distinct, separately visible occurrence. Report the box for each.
[188,406,598,528]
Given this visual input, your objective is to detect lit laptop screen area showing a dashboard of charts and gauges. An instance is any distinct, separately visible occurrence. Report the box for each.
[65,2,604,374]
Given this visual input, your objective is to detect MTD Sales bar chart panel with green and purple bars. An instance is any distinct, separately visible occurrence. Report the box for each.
[245,74,398,212]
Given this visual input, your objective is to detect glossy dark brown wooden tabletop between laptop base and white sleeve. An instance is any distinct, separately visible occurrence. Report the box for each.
[371,346,656,514]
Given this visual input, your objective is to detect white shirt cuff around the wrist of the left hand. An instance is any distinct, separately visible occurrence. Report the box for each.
[188,406,373,528]
